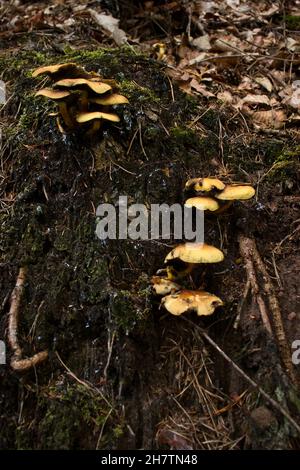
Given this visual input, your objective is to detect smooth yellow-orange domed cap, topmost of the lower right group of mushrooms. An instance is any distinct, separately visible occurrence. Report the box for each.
[165,243,224,263]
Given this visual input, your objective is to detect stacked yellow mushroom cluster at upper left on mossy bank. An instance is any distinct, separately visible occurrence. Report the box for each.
[32,62,128,135]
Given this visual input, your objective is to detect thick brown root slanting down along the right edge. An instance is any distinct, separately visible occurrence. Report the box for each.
[239,234,298,385]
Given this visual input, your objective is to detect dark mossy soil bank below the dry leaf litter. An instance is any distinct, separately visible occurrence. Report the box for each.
[0,4,300,449]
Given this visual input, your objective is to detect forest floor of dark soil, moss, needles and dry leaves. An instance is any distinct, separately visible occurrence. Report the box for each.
[0,0,300,449]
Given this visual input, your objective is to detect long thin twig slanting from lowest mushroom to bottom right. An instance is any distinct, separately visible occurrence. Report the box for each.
[180,317,300,434]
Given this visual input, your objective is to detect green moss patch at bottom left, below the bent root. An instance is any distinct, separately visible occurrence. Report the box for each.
[16,383,116,450]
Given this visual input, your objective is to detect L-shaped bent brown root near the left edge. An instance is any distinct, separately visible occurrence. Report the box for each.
[8,267,48,371]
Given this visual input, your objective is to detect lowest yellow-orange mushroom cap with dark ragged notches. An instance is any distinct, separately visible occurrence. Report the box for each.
[161,290,223,316]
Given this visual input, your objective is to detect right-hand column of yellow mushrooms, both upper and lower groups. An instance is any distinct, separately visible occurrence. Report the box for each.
[151,178,255,316]
